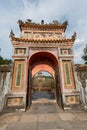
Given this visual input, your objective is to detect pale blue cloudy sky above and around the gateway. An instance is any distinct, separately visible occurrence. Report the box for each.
[0,0,87,64]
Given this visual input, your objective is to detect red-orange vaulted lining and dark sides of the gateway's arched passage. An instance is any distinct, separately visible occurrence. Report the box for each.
[27,51,61,107]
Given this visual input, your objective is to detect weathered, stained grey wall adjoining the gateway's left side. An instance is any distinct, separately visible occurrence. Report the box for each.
[0,65,12,111]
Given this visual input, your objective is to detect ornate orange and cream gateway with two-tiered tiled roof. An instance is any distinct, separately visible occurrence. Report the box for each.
[5,20,80,109]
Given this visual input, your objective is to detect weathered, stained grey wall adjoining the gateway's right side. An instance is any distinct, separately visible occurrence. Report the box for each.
[74,65,87,104]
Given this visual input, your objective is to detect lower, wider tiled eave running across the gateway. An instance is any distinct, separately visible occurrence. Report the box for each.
[11,37,74,43]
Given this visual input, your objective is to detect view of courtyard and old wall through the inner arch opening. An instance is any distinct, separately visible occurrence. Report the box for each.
[32,71,55,102]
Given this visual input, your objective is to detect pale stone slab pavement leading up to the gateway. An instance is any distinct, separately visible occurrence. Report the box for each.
[0,102,87,130]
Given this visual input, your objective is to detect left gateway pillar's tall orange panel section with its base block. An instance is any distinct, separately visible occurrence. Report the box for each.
[4,60,26,109]
